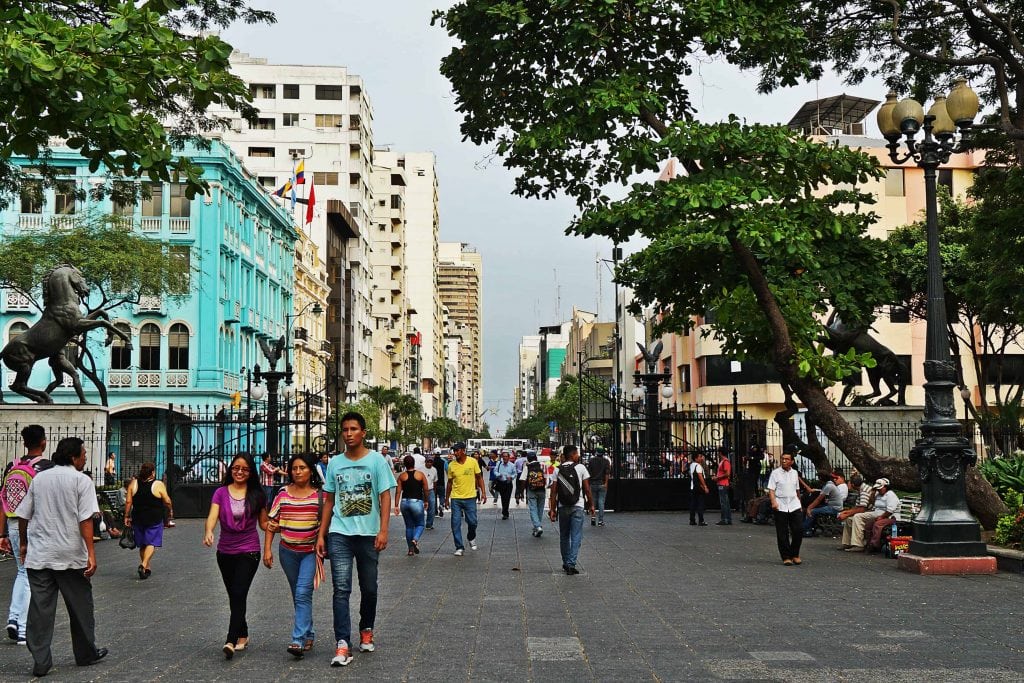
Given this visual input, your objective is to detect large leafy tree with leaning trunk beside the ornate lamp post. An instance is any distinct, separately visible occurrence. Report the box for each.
[435,0,1002,526]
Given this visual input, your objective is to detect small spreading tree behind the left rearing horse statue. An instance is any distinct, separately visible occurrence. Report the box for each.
[0,213,194,405]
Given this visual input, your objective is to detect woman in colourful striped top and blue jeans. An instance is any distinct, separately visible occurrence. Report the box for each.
[263,455,323,657]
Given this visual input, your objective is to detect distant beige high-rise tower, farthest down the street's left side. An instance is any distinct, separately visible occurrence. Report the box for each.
[437,242,483,429]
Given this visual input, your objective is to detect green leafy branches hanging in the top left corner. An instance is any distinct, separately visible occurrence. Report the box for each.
[0,0,274,208]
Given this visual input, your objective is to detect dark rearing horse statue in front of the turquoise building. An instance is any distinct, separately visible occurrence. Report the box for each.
[0,264,131,403]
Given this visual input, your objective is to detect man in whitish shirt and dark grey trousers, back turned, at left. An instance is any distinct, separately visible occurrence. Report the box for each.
[16,436,106,676]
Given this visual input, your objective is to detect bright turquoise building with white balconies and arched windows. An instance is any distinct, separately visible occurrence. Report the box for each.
[0,139,298,478]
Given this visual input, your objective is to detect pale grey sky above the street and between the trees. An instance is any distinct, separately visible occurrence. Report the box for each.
[222,0,885,431]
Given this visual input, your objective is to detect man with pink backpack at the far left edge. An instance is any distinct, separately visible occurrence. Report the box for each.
[0,425,53,645]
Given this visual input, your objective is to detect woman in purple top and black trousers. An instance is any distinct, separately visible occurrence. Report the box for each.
[203,454,267,659]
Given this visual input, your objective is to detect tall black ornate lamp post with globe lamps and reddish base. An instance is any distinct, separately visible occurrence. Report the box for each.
[878,80,994,573]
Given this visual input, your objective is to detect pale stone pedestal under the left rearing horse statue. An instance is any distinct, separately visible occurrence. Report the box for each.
[0,403,111,485]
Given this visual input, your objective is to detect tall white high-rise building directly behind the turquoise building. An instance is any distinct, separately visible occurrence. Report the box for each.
[207,52,375,400]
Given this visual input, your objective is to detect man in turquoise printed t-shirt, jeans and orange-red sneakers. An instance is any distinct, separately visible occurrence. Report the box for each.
[316,412,397,667]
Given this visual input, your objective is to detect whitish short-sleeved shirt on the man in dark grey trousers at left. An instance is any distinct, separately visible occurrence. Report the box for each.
[15,465,99,571]
